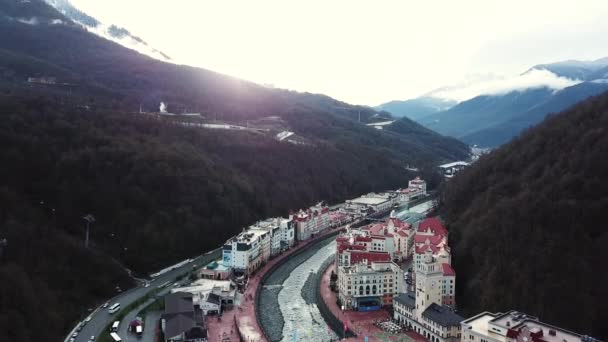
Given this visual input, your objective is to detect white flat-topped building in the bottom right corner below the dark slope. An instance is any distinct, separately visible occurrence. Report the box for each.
[461,310,597,342]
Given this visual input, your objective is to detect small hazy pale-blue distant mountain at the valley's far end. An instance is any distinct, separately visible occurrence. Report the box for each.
[375,96,457,121]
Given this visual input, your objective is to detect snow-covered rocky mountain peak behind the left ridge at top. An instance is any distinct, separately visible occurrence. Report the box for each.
[45,0,171,61]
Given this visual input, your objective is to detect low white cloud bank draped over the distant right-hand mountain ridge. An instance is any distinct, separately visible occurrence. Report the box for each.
[427,69,582,101]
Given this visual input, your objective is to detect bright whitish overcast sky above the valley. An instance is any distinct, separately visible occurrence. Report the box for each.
[71,0,608,105]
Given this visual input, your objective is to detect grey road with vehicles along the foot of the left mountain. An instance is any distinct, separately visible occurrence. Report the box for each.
[66,248,222,342]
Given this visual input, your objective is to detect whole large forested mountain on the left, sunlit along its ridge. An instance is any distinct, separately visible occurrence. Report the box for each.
[0,0,469,342]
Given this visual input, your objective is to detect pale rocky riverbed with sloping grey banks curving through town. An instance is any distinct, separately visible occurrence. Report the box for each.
[259,237,337,341]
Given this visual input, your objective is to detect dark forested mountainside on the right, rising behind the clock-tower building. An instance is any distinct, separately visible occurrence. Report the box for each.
[441,89,608,340]
